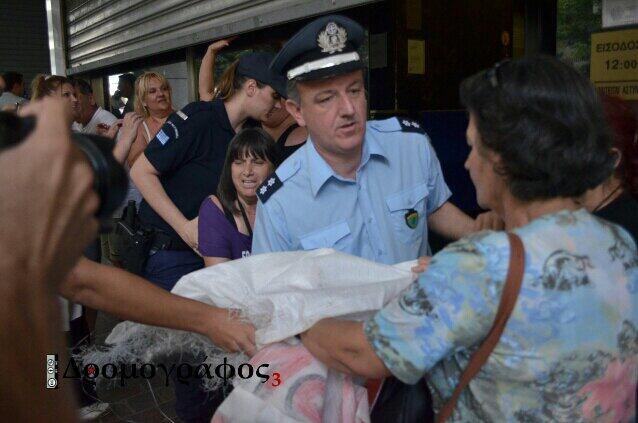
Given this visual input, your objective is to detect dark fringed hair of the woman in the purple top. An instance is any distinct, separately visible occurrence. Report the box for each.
[217,128,280,214]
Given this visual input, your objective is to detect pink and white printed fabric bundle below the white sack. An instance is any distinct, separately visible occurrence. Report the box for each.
[211,342,370,423]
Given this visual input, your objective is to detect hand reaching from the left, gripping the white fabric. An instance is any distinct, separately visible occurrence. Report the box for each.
[204,307,257,356]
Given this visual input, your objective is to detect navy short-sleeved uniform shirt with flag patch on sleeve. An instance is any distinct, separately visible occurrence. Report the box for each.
[140,100,235,239]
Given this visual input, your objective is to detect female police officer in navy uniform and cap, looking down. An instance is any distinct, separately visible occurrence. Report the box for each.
[131,52,284,290]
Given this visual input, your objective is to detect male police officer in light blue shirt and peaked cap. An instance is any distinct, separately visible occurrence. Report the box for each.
[252,15,482,264]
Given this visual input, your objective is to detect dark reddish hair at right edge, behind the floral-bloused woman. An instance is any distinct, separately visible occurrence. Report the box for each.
[600,93,638,198]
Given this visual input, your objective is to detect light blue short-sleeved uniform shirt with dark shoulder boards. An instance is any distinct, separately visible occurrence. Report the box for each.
[252,118,451,264]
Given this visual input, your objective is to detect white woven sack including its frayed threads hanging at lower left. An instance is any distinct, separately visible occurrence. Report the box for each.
[90,249,416,389]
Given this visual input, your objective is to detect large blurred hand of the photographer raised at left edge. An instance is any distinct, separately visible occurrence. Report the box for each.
[0,98,99,284]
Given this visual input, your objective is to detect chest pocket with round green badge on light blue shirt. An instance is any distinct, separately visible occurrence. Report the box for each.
[385,182,429,244]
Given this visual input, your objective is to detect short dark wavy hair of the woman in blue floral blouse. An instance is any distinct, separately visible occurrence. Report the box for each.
[460,56,615,201]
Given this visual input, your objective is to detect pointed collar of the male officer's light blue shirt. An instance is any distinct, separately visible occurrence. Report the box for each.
[304,131,387,197]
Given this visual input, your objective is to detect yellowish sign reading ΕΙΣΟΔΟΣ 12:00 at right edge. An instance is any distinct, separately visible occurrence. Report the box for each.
[589,28,638,100]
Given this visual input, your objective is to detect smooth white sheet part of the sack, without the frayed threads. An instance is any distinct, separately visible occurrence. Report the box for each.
[172,249,415,348]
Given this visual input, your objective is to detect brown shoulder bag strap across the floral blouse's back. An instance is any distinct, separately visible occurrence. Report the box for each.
[436,232,525,423]
